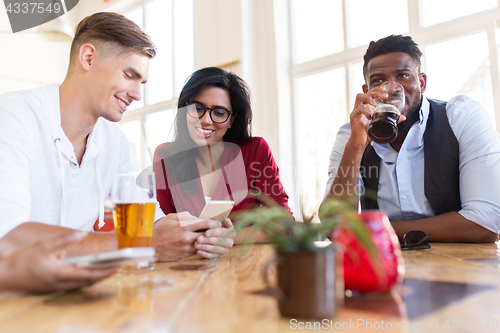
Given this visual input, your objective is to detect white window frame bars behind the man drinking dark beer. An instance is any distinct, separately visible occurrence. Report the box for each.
[286,0,500,214]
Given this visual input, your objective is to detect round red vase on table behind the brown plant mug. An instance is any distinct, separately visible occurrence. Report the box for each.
[332,211,404,292]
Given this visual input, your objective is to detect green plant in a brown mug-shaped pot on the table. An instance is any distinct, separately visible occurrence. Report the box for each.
[235,198,376,319]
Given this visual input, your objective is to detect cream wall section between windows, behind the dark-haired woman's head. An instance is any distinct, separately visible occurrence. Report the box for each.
[194,0,280,159]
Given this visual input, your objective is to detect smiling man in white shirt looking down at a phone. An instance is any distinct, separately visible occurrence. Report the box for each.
[0,13,233,261]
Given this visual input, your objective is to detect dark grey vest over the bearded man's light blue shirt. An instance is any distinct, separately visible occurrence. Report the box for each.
[361,99,462,215]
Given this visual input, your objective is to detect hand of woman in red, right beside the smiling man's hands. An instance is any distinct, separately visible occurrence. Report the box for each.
[194,219,236,259]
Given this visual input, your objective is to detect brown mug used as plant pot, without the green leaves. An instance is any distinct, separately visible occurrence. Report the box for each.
[262,246,344,319]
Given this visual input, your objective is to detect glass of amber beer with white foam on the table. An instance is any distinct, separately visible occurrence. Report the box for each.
[111,172,156,273]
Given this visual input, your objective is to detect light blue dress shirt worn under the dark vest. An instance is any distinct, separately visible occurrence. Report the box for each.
[325,95,500,233]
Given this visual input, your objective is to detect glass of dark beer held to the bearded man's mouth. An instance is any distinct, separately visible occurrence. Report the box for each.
[367,81,405,143]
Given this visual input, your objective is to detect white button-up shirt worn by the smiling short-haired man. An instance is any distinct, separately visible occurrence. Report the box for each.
[0,85,164,237]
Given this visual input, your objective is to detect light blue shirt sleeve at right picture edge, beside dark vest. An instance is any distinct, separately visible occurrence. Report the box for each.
[447,96,500,233]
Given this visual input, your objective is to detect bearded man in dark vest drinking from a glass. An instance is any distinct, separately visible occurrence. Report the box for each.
[326,35,500,242]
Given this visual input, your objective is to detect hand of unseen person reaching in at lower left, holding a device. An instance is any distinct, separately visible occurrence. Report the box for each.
[0,231,118,292]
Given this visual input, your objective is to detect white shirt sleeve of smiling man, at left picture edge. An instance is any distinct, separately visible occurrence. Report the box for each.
[0,97,38,237]
